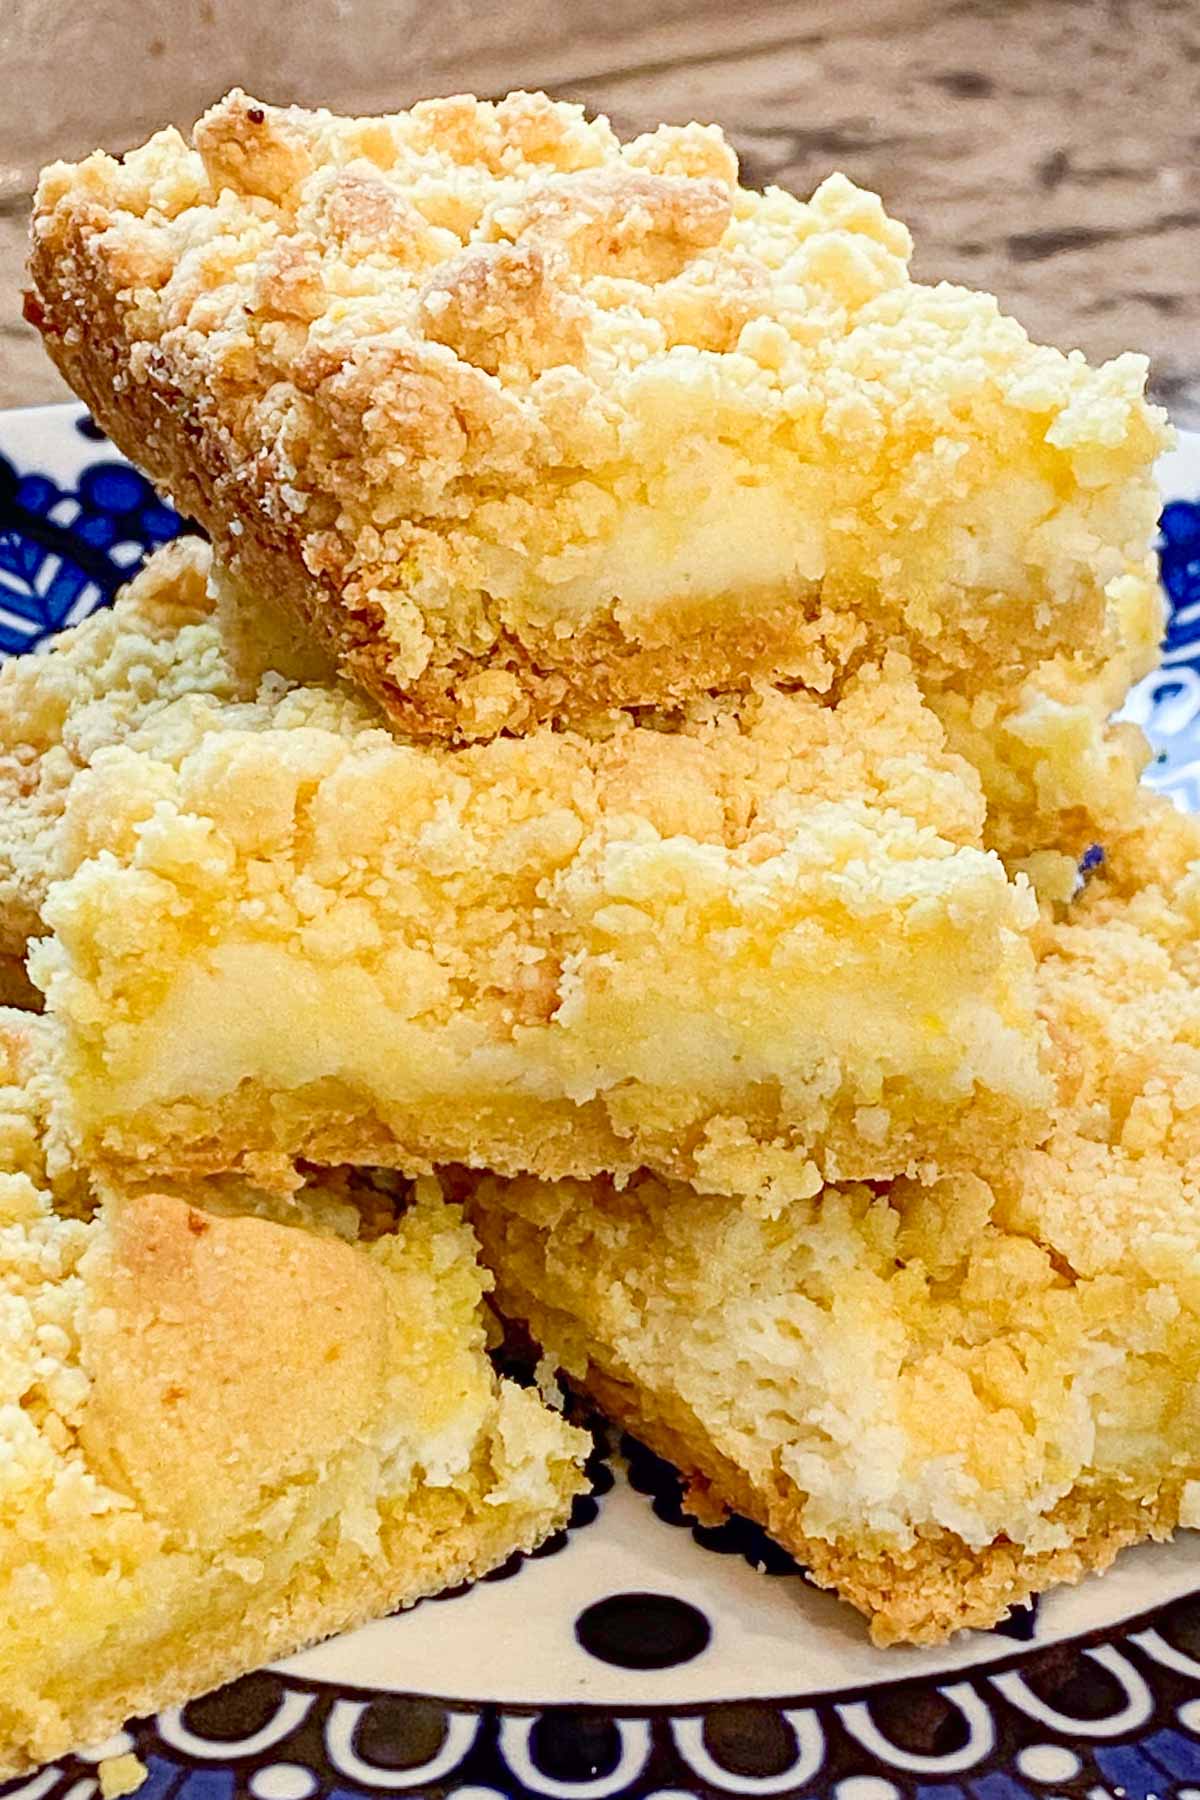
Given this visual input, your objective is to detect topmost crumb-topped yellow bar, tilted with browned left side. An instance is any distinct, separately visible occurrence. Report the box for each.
[29,92,1168,738]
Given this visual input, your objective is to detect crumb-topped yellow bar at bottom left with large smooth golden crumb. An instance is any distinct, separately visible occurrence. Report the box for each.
[0,1013,587,1778]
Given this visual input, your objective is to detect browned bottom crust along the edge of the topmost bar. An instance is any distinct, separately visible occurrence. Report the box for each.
[27,214,1101,742]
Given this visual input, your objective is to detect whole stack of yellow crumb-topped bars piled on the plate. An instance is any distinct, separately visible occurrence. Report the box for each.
[0,81,1200,1771]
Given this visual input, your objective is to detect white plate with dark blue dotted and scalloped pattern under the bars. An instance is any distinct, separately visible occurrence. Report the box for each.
[0,407,1200,1800]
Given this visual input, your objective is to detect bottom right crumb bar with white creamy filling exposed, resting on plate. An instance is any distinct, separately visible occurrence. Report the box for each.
[470,837,1200,1643]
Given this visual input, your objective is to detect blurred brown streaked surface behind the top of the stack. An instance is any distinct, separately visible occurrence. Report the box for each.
[0,0,1200,427]
